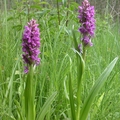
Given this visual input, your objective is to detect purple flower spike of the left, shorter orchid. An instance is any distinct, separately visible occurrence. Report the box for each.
[22,19,40,73]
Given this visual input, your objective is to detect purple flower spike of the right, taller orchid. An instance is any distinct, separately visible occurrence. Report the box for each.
[78,0,95,46]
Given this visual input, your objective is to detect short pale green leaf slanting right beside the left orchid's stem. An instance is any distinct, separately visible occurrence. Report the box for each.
[37,92,57,120]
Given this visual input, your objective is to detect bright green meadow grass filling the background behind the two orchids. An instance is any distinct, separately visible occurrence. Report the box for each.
[0,0,120,120]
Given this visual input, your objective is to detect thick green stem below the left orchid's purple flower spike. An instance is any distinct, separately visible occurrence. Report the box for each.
[25,65,35,120]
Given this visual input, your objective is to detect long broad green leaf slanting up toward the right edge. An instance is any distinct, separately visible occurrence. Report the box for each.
[80,57,118,120]
